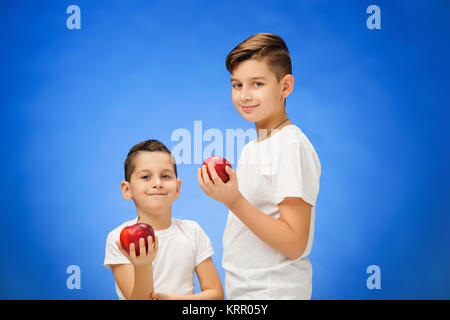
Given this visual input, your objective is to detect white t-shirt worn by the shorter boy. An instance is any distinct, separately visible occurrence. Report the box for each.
[104,217,214,300]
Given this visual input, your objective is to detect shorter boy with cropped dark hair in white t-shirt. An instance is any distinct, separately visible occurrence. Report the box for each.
[104,140,223,300]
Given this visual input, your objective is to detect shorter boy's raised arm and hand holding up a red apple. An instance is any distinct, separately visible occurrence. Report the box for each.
[112,236,158,300]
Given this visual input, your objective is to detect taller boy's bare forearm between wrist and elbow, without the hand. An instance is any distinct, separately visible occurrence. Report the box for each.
[227,195,306,259]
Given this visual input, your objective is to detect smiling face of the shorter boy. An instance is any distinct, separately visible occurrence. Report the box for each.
[121,151,181,213]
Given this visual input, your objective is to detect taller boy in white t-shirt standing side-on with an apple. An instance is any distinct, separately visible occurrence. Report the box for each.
[198,33,321,299]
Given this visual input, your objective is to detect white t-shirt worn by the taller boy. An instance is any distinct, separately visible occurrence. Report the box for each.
[222,125,321,300]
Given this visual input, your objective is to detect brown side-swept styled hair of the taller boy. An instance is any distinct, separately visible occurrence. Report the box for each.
[225,33,292,81]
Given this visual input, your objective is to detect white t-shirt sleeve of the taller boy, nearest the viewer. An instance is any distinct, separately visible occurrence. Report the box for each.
[274,143,321,206]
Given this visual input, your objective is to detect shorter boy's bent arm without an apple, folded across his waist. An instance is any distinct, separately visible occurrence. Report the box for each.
[152,257,223,300]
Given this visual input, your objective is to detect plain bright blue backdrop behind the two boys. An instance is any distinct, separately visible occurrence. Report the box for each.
[0,0,450,299]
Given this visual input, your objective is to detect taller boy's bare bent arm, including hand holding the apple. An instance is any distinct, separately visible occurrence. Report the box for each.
[198,166,311,260]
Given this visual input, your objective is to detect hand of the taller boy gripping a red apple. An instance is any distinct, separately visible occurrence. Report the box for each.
[197,164,241,207]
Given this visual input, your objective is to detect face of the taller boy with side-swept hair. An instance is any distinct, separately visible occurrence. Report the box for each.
[231,59,292,123]
